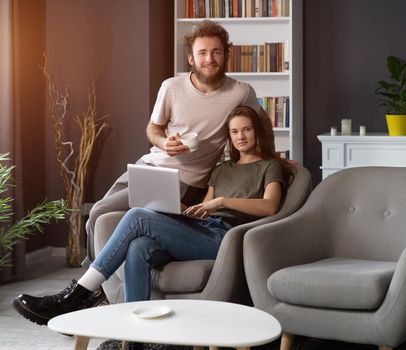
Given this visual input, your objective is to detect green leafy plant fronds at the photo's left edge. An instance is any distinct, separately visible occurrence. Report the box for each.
[0,153,70,270]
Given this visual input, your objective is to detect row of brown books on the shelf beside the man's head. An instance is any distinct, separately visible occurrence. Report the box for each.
[227,40,289,73]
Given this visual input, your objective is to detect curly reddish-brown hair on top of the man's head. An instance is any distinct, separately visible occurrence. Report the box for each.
[183,20,232,58]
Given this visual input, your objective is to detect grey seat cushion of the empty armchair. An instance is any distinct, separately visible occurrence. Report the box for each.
[268,258,396,310]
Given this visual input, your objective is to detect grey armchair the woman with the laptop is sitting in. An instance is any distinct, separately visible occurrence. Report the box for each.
[95,166,311,304]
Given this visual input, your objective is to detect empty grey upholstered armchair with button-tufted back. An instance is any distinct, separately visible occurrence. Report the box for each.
[244,167,406,350]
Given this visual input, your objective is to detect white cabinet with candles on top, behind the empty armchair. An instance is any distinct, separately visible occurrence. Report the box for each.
[317,133,406,179]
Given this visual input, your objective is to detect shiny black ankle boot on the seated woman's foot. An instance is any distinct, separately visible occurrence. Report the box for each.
[13,280,92,325]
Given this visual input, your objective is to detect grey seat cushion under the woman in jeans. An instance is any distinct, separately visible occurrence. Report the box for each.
[151,260,214,293]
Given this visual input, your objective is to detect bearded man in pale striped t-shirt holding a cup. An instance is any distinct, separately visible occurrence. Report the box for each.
[83,21,273,266]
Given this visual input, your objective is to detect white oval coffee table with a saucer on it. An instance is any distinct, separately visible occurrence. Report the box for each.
[48,300,281,350]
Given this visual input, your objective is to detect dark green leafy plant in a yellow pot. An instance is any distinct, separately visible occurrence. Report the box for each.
[375,56,406,136]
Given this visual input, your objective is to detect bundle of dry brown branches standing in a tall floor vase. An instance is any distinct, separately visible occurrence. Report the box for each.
[41,55,108,267]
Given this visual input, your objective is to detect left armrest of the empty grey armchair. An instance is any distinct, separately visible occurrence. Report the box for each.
[243,206,330,312]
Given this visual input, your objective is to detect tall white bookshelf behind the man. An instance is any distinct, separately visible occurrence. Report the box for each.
[174,0,303,162]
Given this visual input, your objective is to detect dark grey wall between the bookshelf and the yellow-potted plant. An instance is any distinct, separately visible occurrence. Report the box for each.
[302,0,406,183]
